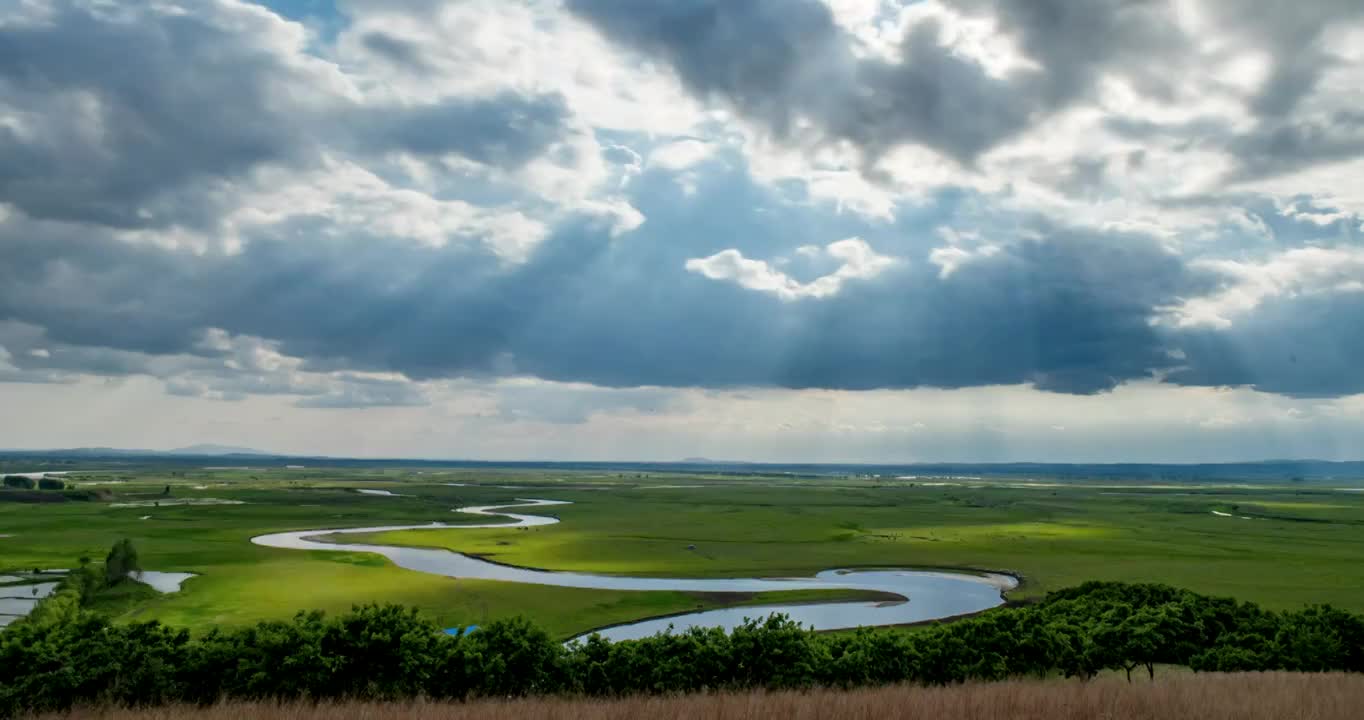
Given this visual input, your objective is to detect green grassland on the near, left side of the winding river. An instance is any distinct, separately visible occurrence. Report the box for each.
[0,472,877,637]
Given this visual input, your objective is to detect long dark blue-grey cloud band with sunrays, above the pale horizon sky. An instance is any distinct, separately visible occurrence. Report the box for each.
[0,173,1364,395]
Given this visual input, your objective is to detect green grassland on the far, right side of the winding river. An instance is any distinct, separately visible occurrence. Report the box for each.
[348,484,1364,610]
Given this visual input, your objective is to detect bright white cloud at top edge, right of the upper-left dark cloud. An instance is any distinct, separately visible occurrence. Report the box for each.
[336,0,705,135]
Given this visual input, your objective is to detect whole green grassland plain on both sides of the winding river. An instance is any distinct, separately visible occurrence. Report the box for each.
[0,468,1364,637]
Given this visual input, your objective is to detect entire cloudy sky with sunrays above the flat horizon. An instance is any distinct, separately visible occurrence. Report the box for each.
[0,0,1364,462]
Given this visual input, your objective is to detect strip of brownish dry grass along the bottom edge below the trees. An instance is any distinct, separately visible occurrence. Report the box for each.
[37,674,1364,720]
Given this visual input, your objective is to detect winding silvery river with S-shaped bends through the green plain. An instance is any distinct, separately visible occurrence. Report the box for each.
[251,500,1018,641]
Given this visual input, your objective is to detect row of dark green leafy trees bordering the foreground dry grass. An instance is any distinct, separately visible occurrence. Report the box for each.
[0,582,1364,716]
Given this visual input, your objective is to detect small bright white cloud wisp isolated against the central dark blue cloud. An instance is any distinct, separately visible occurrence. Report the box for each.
[686,237,900,301]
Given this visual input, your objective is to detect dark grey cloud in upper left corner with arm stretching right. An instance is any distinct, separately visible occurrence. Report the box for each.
[0,0,567,228]
